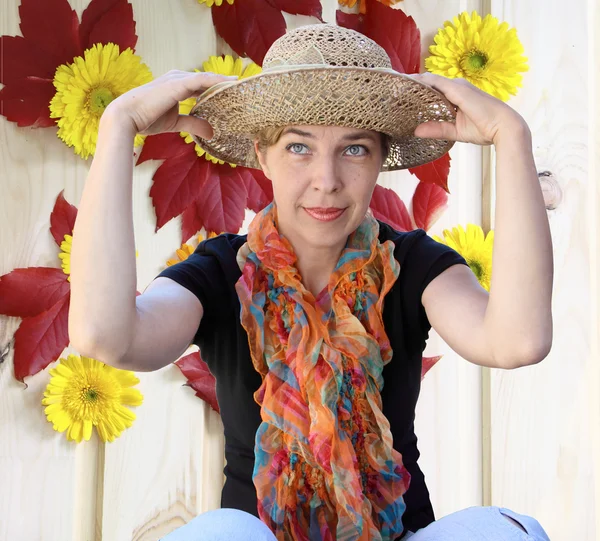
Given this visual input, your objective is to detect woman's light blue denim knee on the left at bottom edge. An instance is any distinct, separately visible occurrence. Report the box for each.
[162,508,276,541]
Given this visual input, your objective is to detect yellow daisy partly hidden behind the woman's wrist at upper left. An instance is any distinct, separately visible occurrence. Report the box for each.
[50,43,152,159]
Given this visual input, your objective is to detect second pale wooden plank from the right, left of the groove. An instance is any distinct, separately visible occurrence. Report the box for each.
[392,0,490,518]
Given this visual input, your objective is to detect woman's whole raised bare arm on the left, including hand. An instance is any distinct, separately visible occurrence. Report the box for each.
[69,71,238,371]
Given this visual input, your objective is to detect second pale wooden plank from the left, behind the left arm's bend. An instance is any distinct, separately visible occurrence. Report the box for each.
[101,0,224,541]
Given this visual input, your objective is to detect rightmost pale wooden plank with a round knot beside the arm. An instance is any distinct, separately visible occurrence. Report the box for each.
[491,0,600,540]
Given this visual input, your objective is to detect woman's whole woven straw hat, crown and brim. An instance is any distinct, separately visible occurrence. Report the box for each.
[190,24,456,171]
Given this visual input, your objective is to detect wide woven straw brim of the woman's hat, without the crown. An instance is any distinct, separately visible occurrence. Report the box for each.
[190,66,456,171]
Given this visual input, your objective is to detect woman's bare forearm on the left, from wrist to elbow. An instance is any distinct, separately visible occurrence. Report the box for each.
[69,110,136,364]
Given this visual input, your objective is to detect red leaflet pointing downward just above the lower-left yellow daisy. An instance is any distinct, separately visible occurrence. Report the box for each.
[15,294,70,381]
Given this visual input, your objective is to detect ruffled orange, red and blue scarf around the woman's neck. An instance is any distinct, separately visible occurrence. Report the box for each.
[236,204,410,541]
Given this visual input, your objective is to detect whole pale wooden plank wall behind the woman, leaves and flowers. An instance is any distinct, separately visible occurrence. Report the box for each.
[0,0,600,541]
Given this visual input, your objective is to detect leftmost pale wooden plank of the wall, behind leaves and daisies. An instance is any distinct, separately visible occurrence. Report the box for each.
[0,120,86,541]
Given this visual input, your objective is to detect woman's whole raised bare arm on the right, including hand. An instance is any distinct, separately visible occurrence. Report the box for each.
[415,74,554,368]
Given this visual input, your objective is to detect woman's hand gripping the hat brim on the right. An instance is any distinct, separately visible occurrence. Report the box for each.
[409,73,527,145]
